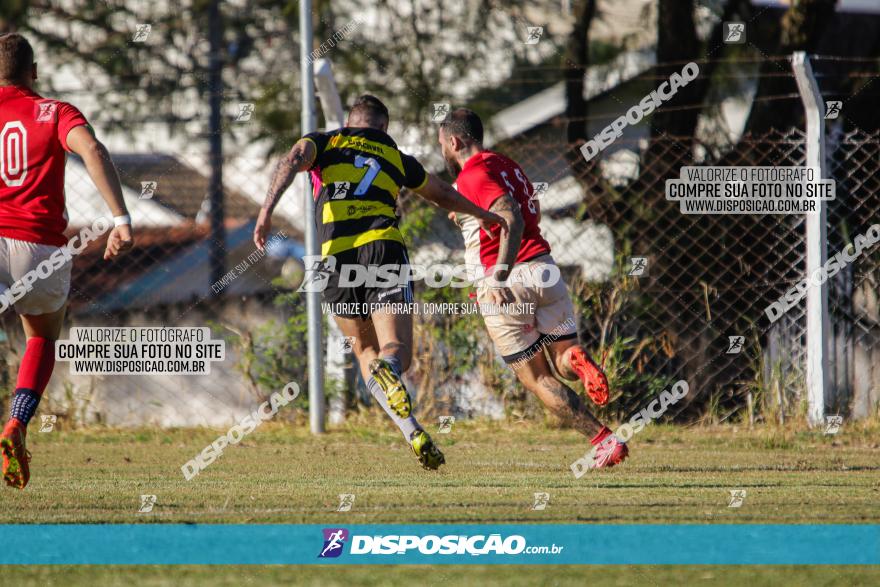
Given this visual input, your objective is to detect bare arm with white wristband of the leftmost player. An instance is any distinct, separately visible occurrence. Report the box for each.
[67,126,134,260]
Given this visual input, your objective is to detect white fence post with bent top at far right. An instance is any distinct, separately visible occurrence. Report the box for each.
[791,51,831,425]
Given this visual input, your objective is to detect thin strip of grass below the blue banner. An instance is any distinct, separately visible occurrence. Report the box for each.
[5,565,880,587]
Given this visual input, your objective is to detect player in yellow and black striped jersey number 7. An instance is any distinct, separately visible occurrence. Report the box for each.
[254,95,507,469]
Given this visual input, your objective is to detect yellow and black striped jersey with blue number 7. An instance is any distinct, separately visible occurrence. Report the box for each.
[303,127,428,257]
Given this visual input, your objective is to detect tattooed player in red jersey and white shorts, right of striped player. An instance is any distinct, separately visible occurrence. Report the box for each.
[439,108,628,467]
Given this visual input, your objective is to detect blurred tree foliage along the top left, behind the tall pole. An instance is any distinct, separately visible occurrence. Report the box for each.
[6,0,557,153]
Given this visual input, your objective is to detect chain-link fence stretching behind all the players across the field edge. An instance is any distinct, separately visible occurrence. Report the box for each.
[4,64,880,426]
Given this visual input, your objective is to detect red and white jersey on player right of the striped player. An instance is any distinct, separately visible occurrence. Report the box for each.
[455,151,550,269]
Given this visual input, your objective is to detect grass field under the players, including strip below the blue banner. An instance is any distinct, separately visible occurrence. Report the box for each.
[0,419,880,585]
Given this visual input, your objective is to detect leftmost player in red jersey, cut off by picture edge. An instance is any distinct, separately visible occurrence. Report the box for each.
[0,33,133,489]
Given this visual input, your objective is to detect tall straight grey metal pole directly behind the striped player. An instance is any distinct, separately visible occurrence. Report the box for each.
[299,0,325,434]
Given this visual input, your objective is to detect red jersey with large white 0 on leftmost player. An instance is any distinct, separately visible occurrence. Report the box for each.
[0,86,88,247]
